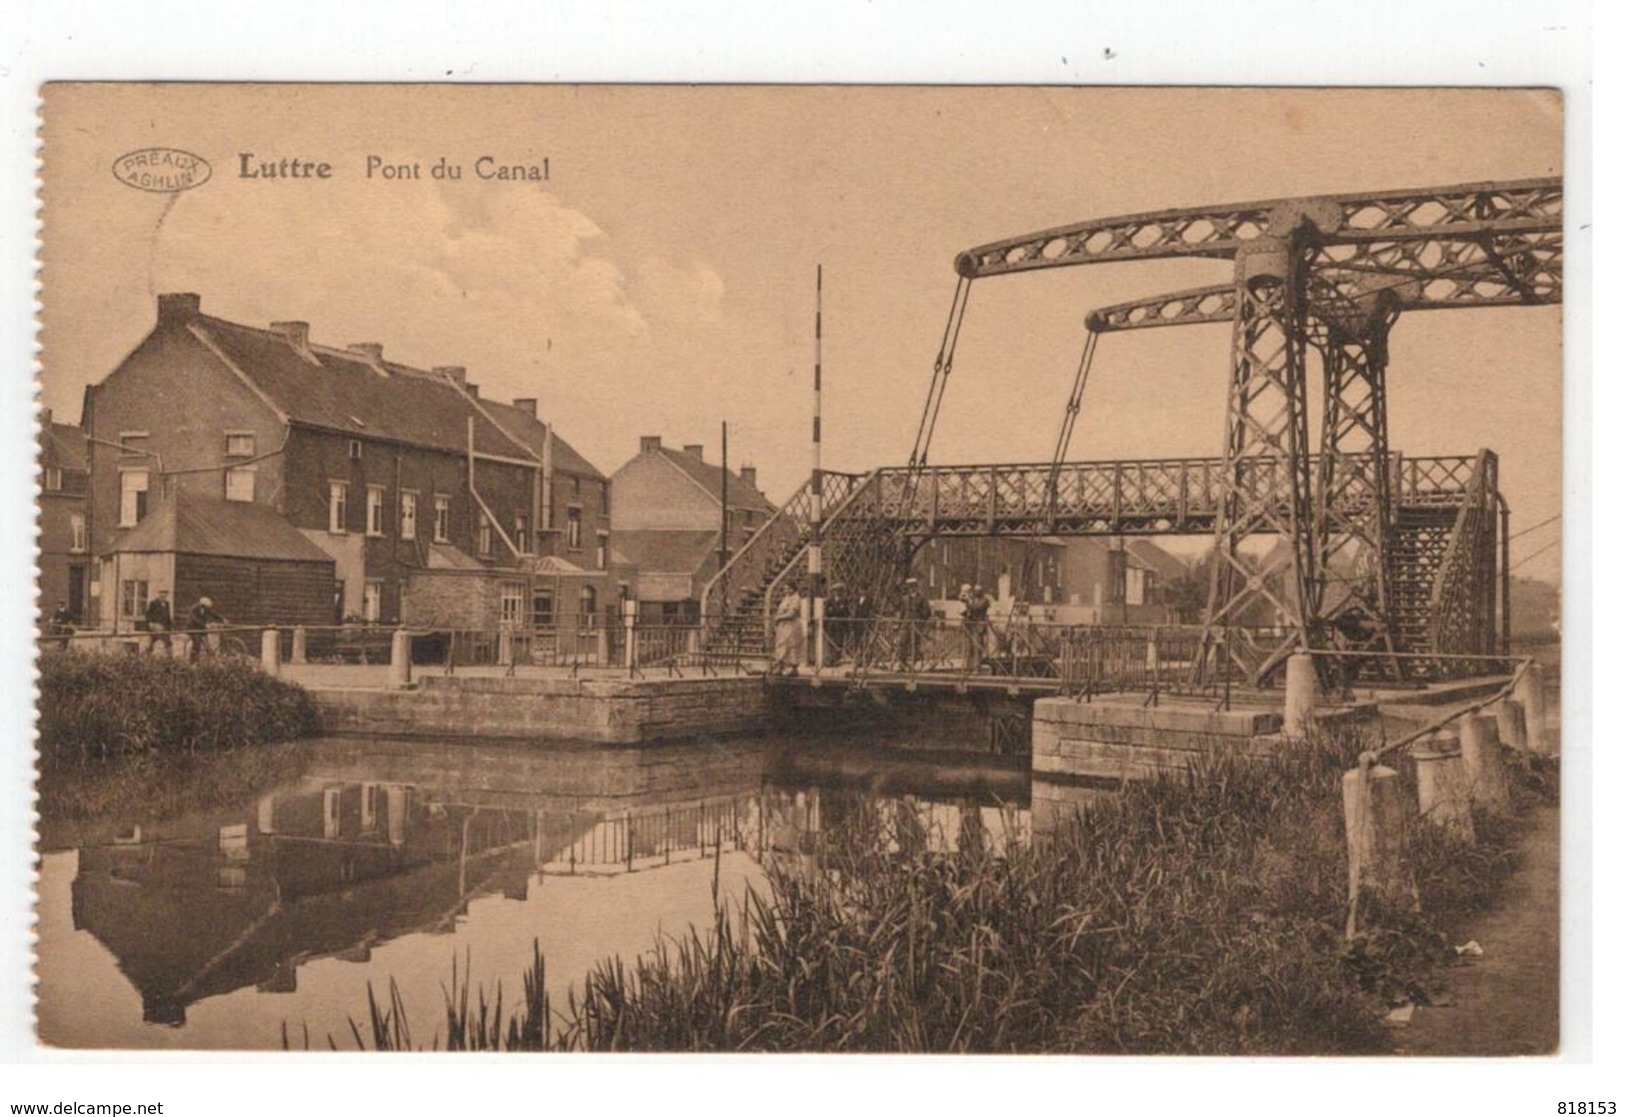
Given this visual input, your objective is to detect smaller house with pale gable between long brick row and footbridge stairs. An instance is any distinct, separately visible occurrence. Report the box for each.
[611,434,774,621]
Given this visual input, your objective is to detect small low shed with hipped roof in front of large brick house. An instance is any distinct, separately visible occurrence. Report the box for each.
[104,489,335,631]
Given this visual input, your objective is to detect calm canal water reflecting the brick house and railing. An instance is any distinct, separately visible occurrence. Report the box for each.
[37,735,1032,1049]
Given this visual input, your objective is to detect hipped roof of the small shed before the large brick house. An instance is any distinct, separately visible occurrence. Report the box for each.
[106,489,333,564]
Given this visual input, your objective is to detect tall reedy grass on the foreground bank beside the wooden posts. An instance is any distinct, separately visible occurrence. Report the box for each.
[316,738,1547,1055]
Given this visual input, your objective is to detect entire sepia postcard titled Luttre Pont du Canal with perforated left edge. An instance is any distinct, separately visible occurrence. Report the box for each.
[34,81,1565,1057]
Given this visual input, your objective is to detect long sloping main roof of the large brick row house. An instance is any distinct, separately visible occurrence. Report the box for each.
[189,314,538,459]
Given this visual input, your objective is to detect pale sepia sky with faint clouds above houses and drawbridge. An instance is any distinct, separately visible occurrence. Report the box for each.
[41,85,1562,580]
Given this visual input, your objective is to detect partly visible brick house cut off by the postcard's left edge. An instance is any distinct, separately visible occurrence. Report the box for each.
[37,408,91,624]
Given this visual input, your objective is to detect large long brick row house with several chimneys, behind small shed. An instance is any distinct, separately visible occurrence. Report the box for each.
[85,294,616,628]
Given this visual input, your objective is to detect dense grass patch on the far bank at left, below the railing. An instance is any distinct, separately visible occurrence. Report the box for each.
[39,649,319,769]
